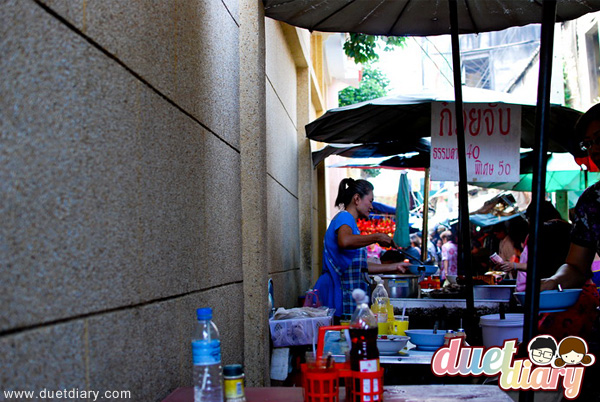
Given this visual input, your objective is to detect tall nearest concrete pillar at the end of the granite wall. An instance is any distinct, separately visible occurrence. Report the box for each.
[239,0,270,387]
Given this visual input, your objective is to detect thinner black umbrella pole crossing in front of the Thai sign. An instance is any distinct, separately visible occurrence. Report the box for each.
[449,0,479,341]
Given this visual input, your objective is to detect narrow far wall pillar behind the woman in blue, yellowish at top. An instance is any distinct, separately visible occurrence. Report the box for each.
[296,67,314,290]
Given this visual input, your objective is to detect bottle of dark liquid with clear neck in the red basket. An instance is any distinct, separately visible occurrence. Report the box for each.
[349,289,383,402]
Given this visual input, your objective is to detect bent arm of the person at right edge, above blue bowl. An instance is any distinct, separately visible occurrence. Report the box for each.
[540,243,596,290]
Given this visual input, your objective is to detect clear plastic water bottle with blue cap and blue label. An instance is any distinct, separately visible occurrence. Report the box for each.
[192,308,223,402]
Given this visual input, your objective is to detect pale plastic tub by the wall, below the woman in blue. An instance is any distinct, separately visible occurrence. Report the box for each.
[269,316,332,347]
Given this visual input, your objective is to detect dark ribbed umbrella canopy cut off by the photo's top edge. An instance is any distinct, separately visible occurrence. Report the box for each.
[263,0,600,36]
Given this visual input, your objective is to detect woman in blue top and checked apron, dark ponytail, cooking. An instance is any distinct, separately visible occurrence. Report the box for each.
[315,178,409,320]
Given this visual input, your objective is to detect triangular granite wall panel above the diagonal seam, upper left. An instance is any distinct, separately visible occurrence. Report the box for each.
[44,0,239,149]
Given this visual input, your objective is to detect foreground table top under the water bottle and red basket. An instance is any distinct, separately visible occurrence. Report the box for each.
[163,385,512,402]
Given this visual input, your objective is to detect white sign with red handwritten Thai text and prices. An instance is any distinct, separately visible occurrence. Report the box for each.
[431,102,521,182]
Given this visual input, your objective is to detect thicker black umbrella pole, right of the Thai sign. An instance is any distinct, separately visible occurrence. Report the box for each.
[519,0,556,401]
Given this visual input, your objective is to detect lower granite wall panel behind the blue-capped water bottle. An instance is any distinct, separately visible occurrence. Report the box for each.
[88,284,244,401]
